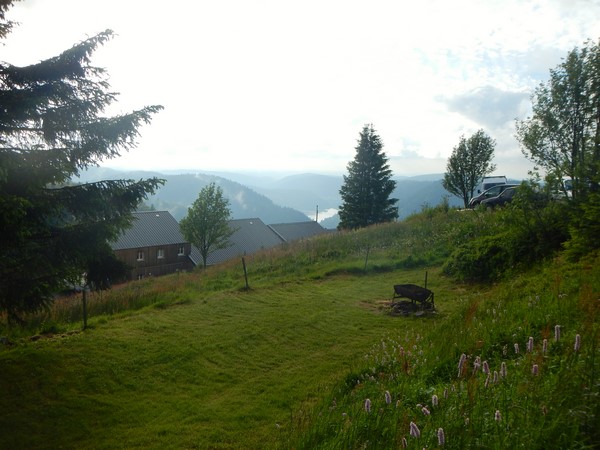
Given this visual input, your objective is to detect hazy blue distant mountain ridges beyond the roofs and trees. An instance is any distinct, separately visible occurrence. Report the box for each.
[79,168,520,229]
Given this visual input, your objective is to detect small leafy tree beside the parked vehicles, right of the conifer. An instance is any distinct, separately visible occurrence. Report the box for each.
[442,130,496,208]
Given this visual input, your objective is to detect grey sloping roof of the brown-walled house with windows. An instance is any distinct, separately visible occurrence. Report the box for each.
[111,211,186,250]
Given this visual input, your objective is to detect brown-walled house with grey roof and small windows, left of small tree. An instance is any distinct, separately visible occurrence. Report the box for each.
[111,211,194,280]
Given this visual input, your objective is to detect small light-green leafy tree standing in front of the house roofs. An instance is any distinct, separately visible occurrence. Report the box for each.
[179,183,235,268]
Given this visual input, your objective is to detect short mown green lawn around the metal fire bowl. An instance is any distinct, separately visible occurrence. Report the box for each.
[0,271,462,449]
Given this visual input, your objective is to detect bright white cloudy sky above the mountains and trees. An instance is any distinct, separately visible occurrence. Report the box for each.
[0,0,600,178]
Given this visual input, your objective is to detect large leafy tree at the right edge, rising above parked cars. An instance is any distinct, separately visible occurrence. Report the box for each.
[517,41,600,199]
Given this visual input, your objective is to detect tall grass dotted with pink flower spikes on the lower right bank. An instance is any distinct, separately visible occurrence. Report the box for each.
[286,251,600,449]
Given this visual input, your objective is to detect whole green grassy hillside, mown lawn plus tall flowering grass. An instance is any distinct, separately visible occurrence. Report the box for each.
[0,207,600,449]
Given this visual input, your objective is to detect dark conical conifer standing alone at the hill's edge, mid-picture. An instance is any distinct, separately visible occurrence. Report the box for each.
[338,125,398,229]
